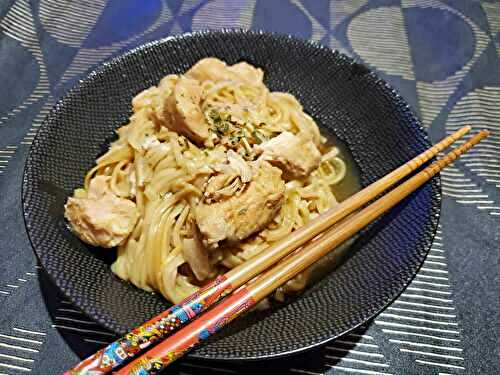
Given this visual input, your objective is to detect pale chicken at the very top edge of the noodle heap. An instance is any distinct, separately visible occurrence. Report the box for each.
[185,57,264,86]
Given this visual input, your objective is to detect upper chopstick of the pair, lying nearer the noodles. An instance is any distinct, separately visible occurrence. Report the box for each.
[63,126,471,374]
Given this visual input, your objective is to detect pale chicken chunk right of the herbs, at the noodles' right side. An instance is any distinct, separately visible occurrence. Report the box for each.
[255,132,321,180]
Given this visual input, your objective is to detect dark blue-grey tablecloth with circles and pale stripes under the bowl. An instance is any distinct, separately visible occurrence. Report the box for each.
[0,0,500,374]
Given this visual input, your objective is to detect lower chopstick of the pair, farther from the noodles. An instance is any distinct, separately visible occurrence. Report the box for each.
[116,130,489,375]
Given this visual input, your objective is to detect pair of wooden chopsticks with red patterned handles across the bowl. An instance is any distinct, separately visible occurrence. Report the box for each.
[64,126,489,375]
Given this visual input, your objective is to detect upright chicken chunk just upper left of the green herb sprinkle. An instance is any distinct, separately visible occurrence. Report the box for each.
[163,77,209,144]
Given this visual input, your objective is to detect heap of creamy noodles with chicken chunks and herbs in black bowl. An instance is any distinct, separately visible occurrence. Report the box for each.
[65,58,358,303]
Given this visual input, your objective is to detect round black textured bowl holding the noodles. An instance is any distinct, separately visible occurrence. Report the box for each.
[23,30,441,359]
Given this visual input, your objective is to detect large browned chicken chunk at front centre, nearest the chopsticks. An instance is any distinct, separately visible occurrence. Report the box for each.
[195,161,285,247]
